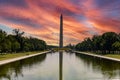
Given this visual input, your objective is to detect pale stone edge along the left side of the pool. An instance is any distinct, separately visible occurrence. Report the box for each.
[0,51,50,66]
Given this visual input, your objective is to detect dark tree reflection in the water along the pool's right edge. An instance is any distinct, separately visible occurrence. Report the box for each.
[76,53,120,79]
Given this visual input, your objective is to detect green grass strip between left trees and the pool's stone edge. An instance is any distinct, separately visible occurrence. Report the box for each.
[0,51,42,61]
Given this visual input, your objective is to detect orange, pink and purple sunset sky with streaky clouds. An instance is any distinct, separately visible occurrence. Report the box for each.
[0,0,120,45]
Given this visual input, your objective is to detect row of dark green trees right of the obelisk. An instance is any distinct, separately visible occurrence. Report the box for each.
[75,32,120,54]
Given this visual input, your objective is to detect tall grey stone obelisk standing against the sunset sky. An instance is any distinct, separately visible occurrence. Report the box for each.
[59,14,63,48]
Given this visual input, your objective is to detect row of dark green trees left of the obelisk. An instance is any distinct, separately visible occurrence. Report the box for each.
[0,29,46,53]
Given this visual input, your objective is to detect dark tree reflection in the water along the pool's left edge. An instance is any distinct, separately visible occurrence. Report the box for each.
[0,54,46,80]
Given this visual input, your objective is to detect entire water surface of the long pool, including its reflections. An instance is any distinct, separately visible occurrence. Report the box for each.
[0,52,120,80]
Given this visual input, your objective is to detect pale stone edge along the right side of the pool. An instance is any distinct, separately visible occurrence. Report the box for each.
[73,51,120,62]
